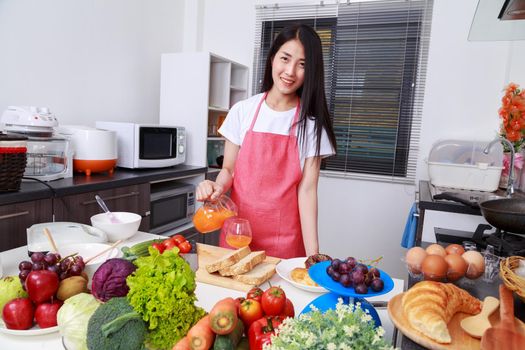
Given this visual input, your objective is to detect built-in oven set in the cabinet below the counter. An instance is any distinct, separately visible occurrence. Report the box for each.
[150,180,195,234]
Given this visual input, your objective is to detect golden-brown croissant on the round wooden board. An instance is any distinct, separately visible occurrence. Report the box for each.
[402,281,481,344]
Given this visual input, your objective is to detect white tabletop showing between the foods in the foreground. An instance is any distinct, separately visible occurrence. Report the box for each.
[0,232,404,350]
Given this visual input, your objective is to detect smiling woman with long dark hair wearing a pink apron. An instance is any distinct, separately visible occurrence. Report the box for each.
[197,25,336,258]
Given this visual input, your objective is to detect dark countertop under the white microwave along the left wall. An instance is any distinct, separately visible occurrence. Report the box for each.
[0,165,207,205]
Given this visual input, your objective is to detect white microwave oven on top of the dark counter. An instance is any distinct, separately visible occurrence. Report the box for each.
[96,121,186,169]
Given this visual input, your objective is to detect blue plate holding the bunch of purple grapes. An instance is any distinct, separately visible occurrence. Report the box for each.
[308,261,394,298]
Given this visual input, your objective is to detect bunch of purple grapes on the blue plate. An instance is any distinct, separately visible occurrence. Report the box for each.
[326,257,385,294]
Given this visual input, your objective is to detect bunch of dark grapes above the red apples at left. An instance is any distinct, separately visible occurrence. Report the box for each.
[18,252,86,285]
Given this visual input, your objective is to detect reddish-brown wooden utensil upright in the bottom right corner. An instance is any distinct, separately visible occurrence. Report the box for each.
[481,284,525,350]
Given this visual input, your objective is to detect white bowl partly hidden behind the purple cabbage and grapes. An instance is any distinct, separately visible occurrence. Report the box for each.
[58,243,121,286]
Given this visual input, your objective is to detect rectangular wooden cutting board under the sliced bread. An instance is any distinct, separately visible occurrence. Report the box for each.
[195,243,281,292]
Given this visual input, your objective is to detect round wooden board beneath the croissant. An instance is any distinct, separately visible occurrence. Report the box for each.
[388,293,525,350]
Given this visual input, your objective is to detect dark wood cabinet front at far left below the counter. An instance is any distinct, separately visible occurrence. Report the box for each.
[0,199,53,251]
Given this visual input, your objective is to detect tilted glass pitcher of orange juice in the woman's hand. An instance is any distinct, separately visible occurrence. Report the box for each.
[193,195,238,233]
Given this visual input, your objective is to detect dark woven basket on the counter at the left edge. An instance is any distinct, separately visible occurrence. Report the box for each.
[0,134,27,192]
